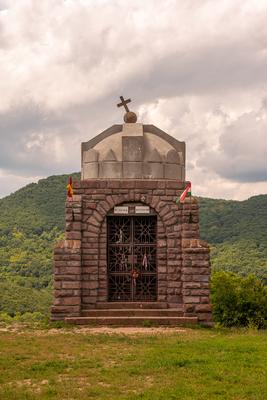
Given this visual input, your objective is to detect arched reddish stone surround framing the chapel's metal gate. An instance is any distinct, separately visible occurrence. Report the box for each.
[82,192,181,306]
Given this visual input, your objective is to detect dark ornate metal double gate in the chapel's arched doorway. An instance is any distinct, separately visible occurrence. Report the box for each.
[107,216,157,301]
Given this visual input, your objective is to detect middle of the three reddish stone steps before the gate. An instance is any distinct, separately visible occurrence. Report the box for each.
[81,308,183,318]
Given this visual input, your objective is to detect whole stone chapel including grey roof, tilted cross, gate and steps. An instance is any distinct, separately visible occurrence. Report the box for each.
[51,97,212,325]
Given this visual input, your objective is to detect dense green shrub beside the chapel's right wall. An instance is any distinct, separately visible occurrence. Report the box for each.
[211,271,267,328]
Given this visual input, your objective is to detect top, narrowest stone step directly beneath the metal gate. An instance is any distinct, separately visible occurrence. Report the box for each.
[86,301,170,310]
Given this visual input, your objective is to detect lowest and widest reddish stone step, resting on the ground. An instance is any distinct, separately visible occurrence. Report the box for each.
[65,317,198,326]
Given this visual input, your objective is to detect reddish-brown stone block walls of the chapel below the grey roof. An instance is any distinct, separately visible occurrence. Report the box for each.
[52,179,211,324]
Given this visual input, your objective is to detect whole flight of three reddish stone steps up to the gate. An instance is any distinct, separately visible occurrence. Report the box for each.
[65,302,198,326]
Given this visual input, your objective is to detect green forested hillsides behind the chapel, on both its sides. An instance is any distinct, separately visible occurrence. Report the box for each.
[0,173,267,315]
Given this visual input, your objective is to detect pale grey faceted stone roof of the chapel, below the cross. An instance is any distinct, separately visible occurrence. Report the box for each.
[82,123,185,181]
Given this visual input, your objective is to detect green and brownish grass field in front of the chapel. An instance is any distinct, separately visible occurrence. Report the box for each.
[0,327,267,400]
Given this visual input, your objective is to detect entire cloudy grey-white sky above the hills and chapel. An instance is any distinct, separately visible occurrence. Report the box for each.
[0,0,267,200]
